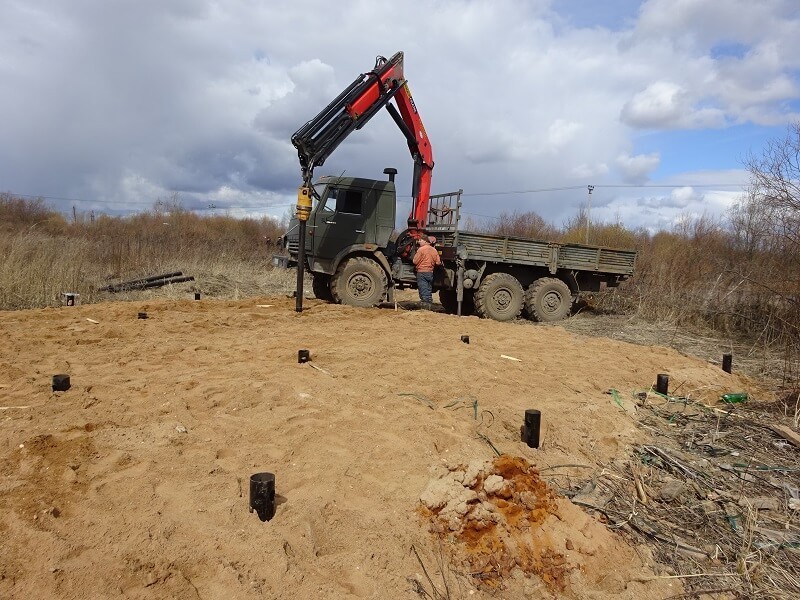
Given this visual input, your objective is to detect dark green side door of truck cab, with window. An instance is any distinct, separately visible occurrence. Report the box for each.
[311,187,367,261]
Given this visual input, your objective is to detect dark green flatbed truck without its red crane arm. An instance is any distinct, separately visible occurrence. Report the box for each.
[274,169,636,321]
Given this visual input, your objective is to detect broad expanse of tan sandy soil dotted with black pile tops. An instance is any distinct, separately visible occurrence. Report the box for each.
[0,297,764,600]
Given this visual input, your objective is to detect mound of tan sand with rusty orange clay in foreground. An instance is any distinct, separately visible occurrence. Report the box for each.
[420,455,668,598]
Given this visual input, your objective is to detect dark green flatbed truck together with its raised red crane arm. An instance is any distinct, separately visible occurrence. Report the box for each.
[274,52,636,321]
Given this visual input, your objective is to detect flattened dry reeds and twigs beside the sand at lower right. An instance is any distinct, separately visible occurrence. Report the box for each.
[559,390,800,598]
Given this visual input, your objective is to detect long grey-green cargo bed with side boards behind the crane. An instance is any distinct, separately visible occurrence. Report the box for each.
[437,231,636,275]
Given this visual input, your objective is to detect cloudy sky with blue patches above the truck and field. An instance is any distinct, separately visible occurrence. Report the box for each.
[0,0,800,228]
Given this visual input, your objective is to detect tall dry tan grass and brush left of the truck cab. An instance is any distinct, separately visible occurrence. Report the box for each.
[0,194,283,310]
